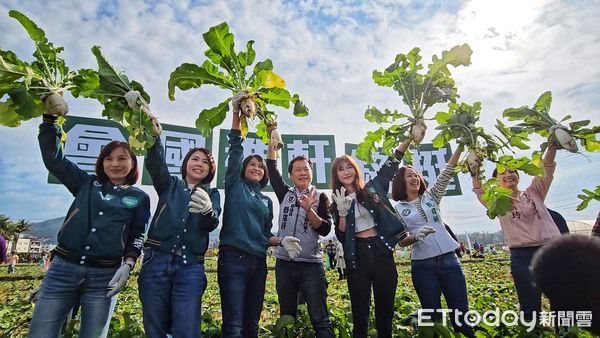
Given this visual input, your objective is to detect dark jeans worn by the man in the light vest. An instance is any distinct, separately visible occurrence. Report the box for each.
[275,259,333,338]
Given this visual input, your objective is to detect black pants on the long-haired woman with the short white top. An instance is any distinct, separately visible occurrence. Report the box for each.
[348,237,398,338]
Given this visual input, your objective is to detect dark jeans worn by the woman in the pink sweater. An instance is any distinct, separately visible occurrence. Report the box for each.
[510,246,542,320]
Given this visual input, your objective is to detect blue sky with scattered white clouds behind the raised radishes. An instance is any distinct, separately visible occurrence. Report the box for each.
[0,0,600,233]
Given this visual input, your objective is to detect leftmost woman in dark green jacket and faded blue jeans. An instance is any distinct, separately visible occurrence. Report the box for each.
[29,106,150,338]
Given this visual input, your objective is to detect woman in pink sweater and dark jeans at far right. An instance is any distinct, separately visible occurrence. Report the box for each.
[472,140,560,318]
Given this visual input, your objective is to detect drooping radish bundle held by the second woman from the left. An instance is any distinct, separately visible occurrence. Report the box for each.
[92,46,155,155]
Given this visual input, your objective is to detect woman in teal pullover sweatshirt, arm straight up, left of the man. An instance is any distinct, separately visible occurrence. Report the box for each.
[217,92,301,337]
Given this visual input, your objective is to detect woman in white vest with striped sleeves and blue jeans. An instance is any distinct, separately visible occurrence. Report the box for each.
[392,146,474,337]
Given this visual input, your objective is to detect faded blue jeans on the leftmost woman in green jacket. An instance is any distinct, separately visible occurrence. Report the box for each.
[29,256,118,338]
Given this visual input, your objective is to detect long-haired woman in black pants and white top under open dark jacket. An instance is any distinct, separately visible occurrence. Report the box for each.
[331,141,409,337]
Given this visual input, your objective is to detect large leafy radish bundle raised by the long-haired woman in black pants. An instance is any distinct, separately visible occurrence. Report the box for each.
[356,44,473,163]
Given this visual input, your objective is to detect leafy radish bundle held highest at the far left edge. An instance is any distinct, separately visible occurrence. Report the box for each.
[0,10,98,127]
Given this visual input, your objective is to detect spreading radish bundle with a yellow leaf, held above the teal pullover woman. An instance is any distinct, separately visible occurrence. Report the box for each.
[169,22,308,143]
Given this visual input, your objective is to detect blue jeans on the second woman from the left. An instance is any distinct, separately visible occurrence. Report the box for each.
[138,248,207,338]
